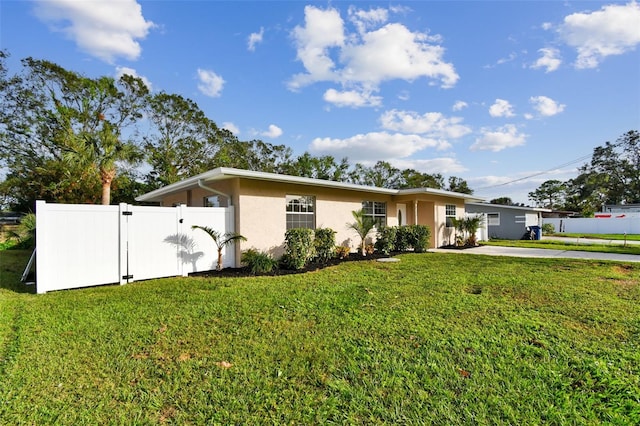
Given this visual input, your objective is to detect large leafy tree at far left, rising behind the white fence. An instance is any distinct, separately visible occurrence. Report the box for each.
[0,56,148,205]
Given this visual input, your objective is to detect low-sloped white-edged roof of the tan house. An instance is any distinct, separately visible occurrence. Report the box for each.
[136,167,481,202]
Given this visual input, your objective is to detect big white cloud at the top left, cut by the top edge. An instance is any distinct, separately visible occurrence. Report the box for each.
[35,0,154,63]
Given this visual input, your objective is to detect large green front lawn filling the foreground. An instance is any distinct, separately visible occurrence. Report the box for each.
[0,252,640,425]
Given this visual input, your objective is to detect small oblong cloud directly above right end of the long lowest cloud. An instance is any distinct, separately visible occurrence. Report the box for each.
[380,109,471,139]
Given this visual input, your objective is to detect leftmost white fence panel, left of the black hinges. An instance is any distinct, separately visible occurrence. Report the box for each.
[36,201,120,293]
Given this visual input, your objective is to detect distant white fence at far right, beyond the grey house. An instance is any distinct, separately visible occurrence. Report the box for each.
[542,217,640,234]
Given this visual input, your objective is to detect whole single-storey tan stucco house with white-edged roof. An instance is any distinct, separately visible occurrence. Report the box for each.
[136,167,480,259]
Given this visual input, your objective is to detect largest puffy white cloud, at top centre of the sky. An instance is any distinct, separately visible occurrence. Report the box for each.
[288,6,459,106]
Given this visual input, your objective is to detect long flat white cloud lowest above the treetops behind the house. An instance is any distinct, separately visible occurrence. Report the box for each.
[310,132,451,162]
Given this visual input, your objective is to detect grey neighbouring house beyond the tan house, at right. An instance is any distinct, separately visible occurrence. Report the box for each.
[465,202,551,240]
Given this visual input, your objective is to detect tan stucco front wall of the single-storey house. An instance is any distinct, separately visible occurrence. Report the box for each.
[152,178,464,266]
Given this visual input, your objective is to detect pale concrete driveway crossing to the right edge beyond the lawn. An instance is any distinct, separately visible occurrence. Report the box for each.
[429,246,640,262]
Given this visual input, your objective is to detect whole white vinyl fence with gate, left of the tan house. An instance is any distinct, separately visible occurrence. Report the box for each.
[36,201,235,293]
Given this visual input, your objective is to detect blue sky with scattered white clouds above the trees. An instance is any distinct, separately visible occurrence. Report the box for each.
[0,0,640,204]
